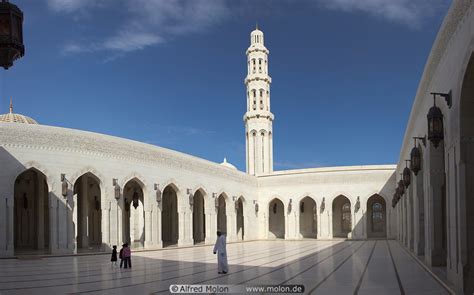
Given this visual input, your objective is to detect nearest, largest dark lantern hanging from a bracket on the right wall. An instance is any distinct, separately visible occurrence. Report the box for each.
[426,91,452,148]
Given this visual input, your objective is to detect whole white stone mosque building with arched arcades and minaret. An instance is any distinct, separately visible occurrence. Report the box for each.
[0,0,474,290]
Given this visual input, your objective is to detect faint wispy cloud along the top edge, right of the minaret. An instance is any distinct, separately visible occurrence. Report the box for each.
[316,0,449,27]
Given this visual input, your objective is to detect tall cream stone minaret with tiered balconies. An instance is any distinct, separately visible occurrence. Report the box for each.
[244,26,274,175]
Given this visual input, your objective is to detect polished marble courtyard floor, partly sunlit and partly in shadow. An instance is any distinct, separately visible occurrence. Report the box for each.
[0,240,449,295]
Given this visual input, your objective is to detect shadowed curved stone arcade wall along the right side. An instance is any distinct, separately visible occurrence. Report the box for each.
[395,0,474,294]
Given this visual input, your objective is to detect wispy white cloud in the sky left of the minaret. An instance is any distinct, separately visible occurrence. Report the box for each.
[48,0,228,56]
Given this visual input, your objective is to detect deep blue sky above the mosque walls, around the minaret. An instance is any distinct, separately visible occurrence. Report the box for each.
[0,0,450,171]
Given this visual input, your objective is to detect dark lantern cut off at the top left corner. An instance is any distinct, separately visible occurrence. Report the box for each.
[0,0,25,69]
